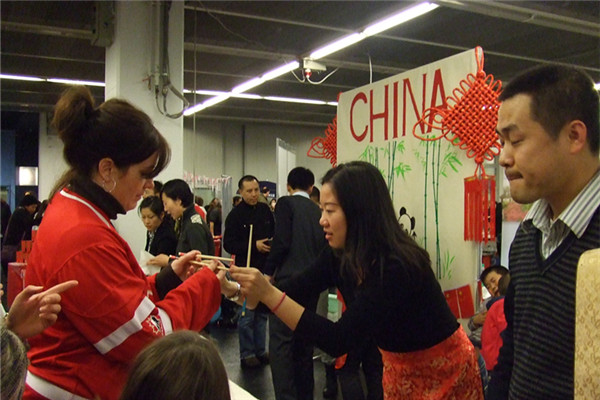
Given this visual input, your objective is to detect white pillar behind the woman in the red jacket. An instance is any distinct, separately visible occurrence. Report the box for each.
[105,1,184,257]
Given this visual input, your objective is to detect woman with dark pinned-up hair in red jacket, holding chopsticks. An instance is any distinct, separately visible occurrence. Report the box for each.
[24,86,237,400]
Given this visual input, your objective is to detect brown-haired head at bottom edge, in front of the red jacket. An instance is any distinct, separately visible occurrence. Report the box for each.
[121,331,231,400]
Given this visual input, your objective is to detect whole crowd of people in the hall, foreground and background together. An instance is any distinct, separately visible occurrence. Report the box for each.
[1,61,600,400]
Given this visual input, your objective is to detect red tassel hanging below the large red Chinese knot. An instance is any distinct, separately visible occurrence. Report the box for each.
[464,172,496,243]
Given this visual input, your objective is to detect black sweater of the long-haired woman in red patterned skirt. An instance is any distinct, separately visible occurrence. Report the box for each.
[284,247,459,357]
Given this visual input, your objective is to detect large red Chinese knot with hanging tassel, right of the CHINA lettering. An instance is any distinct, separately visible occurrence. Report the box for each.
[413,47,502,243]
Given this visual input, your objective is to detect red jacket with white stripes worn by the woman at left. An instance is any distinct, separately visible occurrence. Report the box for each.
[23,190,221,400]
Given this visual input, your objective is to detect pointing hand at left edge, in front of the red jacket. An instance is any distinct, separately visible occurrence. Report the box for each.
[6,281,78,339]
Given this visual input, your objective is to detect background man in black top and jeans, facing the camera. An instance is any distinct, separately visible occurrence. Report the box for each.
[223,175,275,368]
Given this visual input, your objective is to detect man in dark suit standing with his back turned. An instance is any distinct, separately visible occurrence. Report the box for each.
[263,167,327,400]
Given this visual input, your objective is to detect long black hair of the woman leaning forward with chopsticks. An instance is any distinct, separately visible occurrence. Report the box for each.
[321,161,431,284]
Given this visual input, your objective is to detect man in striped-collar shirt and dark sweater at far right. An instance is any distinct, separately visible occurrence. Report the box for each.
[487,65,600,400]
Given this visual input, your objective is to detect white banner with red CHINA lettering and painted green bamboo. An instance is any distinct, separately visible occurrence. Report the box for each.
[337,49,481,290]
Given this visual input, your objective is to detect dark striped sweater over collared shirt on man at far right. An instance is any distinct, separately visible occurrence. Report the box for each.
[488,208,600,400]
